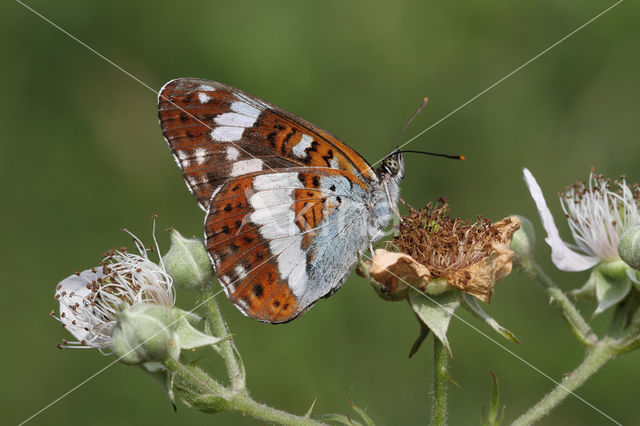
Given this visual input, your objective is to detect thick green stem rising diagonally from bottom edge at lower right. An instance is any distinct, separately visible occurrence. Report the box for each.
[512,339,615,426]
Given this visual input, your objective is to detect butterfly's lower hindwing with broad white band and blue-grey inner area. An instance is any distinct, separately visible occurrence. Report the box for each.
[205,167,370,323]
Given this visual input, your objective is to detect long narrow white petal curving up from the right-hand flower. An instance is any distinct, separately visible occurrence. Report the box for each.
[523,168,600,272]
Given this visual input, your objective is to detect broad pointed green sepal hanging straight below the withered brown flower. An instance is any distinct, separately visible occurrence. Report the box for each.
[409,289,460,355]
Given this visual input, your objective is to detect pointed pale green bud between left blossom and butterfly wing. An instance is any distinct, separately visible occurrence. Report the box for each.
[163,229,213,291]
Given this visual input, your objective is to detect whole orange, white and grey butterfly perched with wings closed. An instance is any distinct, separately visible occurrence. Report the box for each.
[158,78,404,323]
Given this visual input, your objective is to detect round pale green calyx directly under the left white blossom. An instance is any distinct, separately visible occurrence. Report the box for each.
[111,303,180,364]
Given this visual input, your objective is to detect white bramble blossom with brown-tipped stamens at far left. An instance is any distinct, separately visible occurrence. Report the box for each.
[55,235,175,352]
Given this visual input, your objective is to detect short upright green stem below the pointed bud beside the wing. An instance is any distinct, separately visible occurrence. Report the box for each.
[202,286,245,390]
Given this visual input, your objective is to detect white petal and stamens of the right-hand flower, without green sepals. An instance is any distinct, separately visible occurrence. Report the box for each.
[524,169,640,271]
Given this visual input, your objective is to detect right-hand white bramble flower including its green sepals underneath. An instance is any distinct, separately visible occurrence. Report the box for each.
[524,169,640,314]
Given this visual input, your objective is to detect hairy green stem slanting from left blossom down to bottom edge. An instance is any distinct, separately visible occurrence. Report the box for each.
[165,359,324,426]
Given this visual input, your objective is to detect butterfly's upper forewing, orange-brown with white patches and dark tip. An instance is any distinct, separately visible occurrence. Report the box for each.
[158,78,377,211]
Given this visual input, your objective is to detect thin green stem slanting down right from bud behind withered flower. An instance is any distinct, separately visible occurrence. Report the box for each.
[521,259,598,348]
